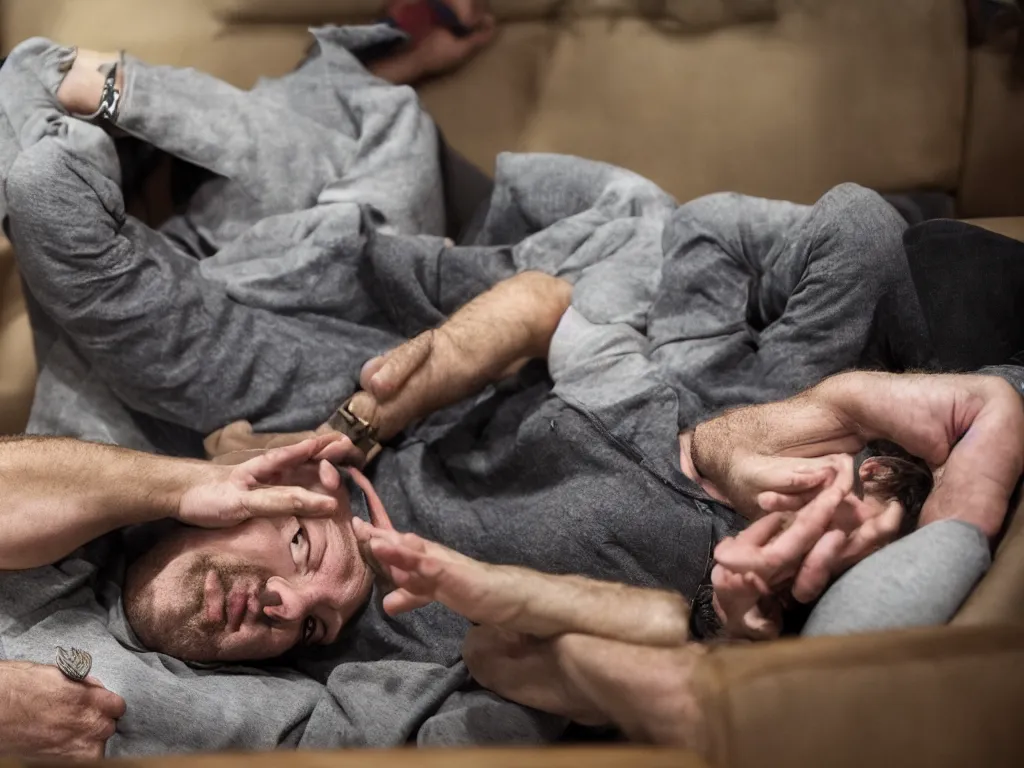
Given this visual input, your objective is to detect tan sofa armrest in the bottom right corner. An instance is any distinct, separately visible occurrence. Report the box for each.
[694,626,1024,768]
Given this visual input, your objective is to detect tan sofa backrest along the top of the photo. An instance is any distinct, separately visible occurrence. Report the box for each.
[0,0,984,210]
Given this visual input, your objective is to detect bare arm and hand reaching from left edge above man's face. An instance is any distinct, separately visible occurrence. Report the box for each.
[0,437,340,570]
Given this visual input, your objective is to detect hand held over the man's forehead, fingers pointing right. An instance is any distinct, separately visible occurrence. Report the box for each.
[176,435,344,528]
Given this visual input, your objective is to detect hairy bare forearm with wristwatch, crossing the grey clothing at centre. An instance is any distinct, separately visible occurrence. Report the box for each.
[351,272,572,439]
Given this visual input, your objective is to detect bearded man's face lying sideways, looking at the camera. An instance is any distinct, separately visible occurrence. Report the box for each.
[124,495,373,662]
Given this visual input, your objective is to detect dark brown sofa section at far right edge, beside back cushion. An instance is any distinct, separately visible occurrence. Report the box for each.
[958,43,1024,216]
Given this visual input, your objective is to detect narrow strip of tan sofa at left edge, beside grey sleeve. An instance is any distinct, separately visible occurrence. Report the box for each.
[0,237,36,434]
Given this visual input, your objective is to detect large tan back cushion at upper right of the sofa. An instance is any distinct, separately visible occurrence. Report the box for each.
[520,0,967,201]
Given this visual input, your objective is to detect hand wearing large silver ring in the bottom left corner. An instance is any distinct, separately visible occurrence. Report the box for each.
[0,662,125,760]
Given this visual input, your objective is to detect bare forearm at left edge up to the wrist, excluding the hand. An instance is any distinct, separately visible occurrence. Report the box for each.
[0,437,209,570]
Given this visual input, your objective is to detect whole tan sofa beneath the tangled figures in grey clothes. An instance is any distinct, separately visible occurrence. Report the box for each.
[0,0,1024,768]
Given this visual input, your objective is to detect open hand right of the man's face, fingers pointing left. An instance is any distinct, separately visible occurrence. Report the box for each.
[352,518,526,628]
